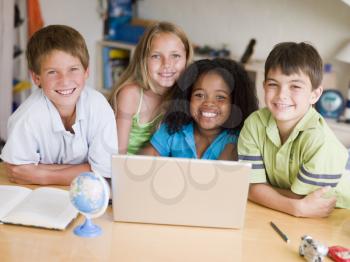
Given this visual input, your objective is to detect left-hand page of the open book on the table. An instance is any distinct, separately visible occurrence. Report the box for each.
[0,185,32,220]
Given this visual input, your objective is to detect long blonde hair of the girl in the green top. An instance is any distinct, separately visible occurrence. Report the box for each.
[109,22,193,108]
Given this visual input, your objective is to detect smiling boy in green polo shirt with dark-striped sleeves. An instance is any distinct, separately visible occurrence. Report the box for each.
[238,42,350,217]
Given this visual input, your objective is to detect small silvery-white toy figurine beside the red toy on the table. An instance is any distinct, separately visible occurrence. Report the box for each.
[299,235,328,262]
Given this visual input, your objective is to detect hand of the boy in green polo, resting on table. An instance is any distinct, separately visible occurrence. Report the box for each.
[298,187,337,217]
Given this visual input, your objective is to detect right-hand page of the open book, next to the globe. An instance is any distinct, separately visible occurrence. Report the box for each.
[3,187,78,230]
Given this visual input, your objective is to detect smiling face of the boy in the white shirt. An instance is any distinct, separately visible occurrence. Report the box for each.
[32,50,88,112]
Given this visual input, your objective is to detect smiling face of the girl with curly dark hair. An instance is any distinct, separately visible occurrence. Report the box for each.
[190,72,232,133]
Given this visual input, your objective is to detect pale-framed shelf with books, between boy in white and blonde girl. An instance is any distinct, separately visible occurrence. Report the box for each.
[97,40,136,96]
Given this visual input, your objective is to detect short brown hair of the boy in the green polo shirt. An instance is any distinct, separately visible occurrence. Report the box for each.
[265,42,323,89]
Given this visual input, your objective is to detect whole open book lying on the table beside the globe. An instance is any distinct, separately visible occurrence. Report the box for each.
[0,185,78,230]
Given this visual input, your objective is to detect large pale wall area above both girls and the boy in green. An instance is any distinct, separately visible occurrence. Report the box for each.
[138,0,350,93]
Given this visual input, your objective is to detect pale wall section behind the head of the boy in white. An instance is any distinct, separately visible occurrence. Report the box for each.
[40,0,103,87]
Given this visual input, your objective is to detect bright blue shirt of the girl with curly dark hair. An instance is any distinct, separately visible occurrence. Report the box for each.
[151,123,237,160]
